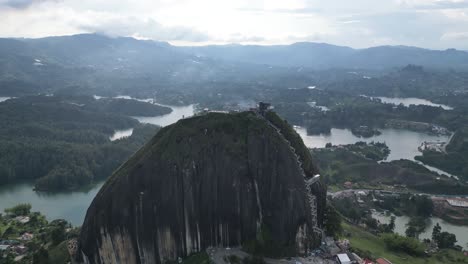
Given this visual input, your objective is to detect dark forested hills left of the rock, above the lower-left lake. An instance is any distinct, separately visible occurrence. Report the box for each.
[0,96,161,191]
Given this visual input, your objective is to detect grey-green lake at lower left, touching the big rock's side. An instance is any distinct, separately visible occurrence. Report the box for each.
[0,182,104,226]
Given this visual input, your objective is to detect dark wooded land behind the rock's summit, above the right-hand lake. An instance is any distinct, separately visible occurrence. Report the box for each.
[272,88,468,134]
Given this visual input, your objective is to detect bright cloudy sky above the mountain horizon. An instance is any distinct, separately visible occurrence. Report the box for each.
[0,0,468,50]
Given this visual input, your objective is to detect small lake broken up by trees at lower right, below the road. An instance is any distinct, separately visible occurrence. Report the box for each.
[372,212,468,249]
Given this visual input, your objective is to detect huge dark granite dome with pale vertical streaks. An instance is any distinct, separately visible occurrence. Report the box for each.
[75,112,326,264]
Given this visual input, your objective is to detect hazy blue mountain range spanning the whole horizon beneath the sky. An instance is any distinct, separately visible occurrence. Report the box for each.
[0,34,468,69]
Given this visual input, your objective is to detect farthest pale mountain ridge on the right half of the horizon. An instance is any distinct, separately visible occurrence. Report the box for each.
[183,42,468,69]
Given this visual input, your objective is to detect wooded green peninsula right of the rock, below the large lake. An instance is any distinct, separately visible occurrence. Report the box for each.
[311,142,468,194]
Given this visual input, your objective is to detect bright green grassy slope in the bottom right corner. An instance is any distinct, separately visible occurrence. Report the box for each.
[343,223,468,264]
